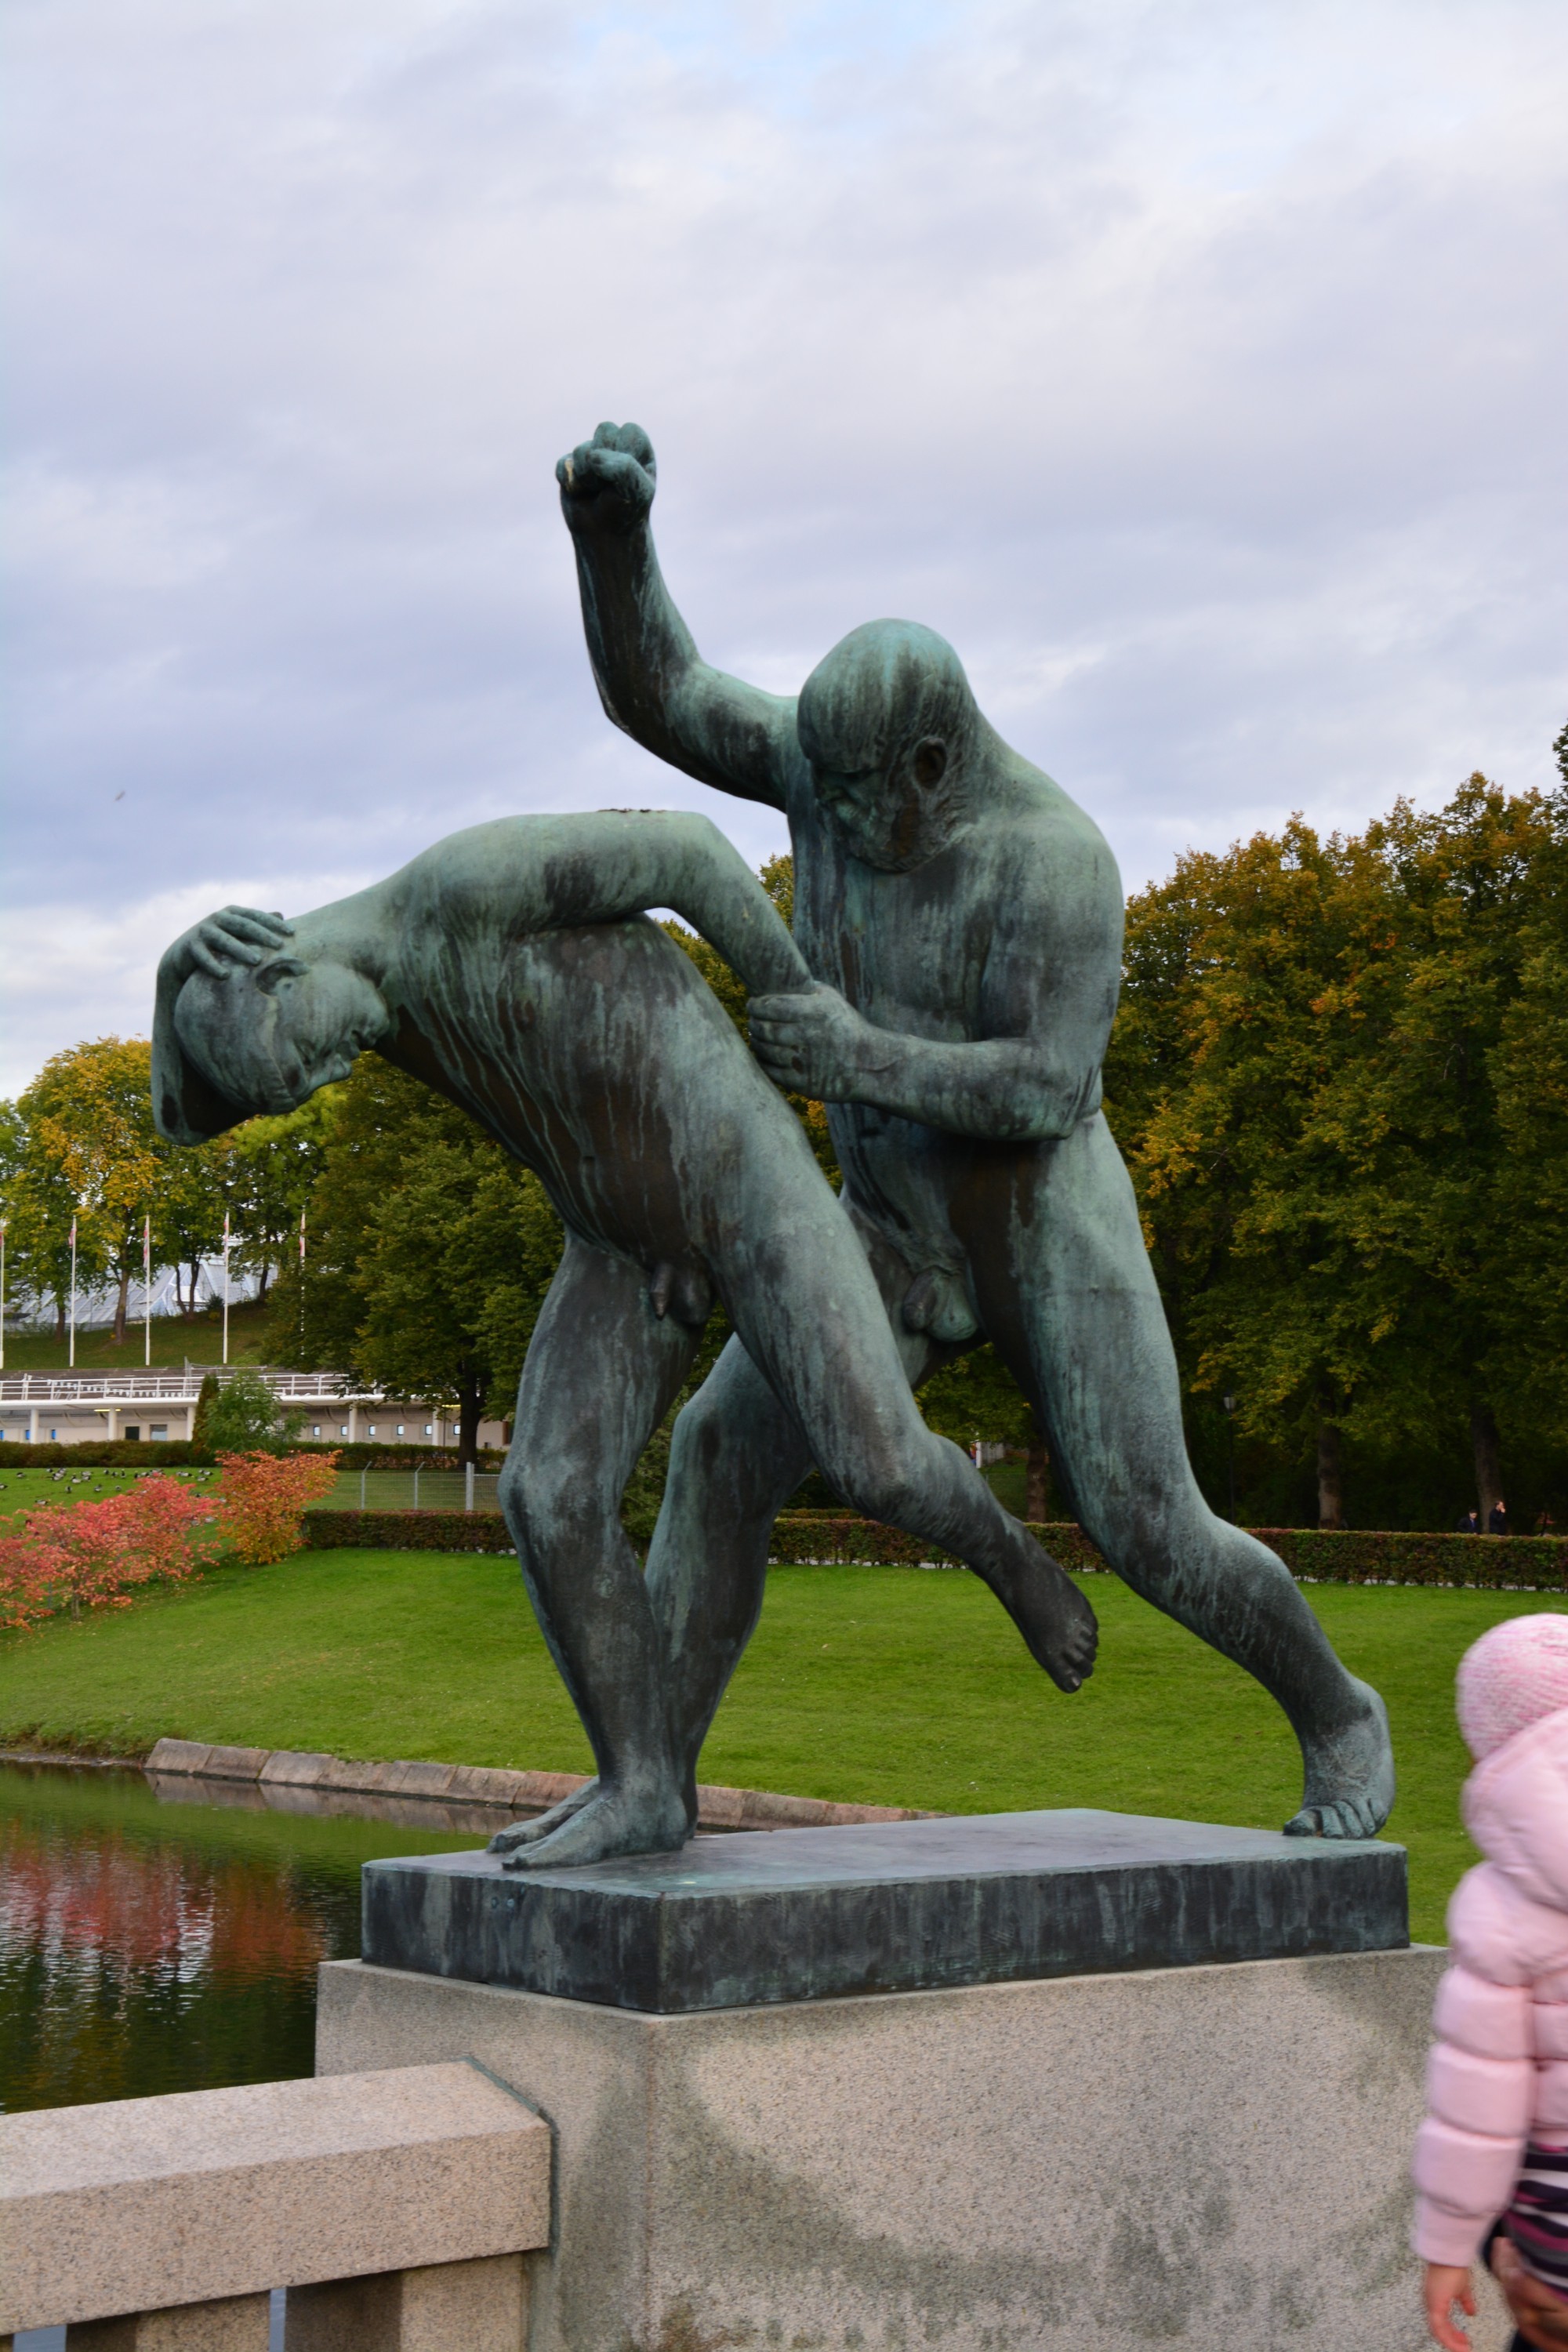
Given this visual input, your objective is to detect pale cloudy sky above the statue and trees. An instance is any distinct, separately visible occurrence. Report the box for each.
[0,0,1568,1091]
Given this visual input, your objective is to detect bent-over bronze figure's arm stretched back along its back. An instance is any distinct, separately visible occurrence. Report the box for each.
[411,809,811,995]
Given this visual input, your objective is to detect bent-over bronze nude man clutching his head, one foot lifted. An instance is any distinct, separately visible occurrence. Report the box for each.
[153,814,1095,1867]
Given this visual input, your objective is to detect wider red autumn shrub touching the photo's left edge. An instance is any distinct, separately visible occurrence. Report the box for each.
[0,1477,214,1625]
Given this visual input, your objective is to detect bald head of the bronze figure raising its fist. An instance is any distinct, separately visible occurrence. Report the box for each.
[797,621,980,873]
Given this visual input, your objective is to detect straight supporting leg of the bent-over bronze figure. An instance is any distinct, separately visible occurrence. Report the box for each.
[492,1237,696,1867]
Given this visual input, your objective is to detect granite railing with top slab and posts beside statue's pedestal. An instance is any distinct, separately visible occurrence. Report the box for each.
[0,2060,550,2352]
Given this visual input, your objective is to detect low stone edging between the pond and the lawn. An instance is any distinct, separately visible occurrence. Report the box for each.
[143,1740,938,1830]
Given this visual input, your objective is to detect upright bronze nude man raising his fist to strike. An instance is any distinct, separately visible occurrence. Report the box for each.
[557,426,1394,1837]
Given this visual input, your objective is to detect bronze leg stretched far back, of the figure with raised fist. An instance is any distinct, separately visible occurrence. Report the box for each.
[975,1120,1394,1837]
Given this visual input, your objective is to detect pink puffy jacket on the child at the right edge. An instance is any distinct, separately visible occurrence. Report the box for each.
[1413,1708,1568,2265]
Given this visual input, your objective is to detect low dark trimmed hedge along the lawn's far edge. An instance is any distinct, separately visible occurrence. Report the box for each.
[306,1510,1568,1592]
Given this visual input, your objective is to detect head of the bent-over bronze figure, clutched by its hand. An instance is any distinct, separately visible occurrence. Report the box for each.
[174,955,390,1117]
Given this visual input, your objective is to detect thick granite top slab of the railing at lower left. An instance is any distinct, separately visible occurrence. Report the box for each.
[0,2058,550,2338]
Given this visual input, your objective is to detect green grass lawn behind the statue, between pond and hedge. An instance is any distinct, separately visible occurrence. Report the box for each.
[0,1552,1540,1940]
